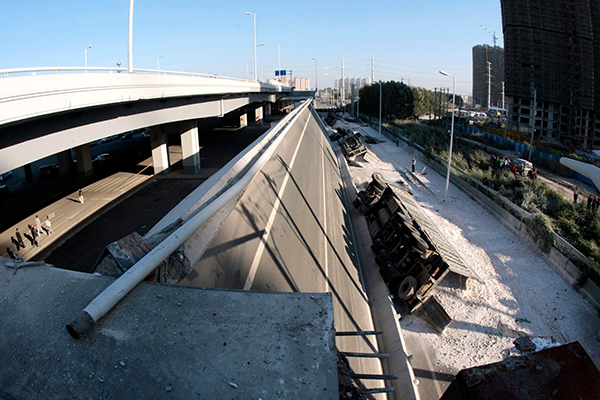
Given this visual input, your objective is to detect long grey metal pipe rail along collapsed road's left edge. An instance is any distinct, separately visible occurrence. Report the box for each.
[66,100,312,339]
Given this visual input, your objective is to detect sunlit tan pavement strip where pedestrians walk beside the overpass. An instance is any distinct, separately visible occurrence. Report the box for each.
[0,172,154,261]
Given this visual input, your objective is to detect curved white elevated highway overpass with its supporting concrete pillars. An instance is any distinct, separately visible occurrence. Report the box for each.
[0,67,291,176]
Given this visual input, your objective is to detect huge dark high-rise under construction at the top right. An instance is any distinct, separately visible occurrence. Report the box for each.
[501,0,600,149]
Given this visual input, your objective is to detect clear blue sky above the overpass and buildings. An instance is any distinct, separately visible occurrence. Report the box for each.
[0,0,503,94]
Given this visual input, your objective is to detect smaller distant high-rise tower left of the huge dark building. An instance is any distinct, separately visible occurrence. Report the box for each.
[473,44,504,108]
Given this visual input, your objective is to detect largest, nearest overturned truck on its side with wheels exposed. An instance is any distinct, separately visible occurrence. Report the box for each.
[353,173,479,332]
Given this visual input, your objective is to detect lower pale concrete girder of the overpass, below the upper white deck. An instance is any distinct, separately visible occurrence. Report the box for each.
[0,93,281,177]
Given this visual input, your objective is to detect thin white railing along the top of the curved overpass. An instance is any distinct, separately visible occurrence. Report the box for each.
[0,67,268,82]
